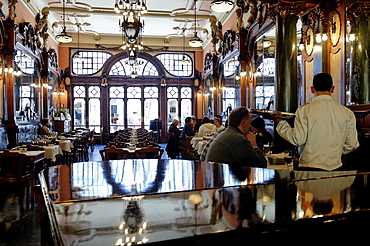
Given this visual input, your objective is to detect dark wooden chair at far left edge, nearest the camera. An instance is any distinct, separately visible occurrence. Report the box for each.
[0,150,31,212]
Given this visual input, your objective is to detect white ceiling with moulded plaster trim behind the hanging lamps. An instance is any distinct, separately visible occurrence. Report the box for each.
[28,0,235,50]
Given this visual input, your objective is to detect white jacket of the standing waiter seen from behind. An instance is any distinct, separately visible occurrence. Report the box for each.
[276,95,359,170]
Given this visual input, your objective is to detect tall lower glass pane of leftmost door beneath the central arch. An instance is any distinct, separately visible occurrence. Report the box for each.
[109,99,125,133]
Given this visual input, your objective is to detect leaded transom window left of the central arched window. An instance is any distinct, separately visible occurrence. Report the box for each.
[72,51,112,75]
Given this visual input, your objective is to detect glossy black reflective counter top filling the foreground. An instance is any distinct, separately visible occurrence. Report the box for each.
[39,159,370,245]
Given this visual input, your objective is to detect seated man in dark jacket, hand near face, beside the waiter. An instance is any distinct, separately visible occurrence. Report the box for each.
[206,107,267,167]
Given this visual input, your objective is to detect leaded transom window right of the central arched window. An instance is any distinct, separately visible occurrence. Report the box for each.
[156,53,193,77]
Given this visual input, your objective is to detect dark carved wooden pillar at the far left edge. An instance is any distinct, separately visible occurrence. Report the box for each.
[3,18,18,148]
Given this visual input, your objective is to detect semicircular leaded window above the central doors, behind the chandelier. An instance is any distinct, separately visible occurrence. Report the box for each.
[109,58,159,76]
